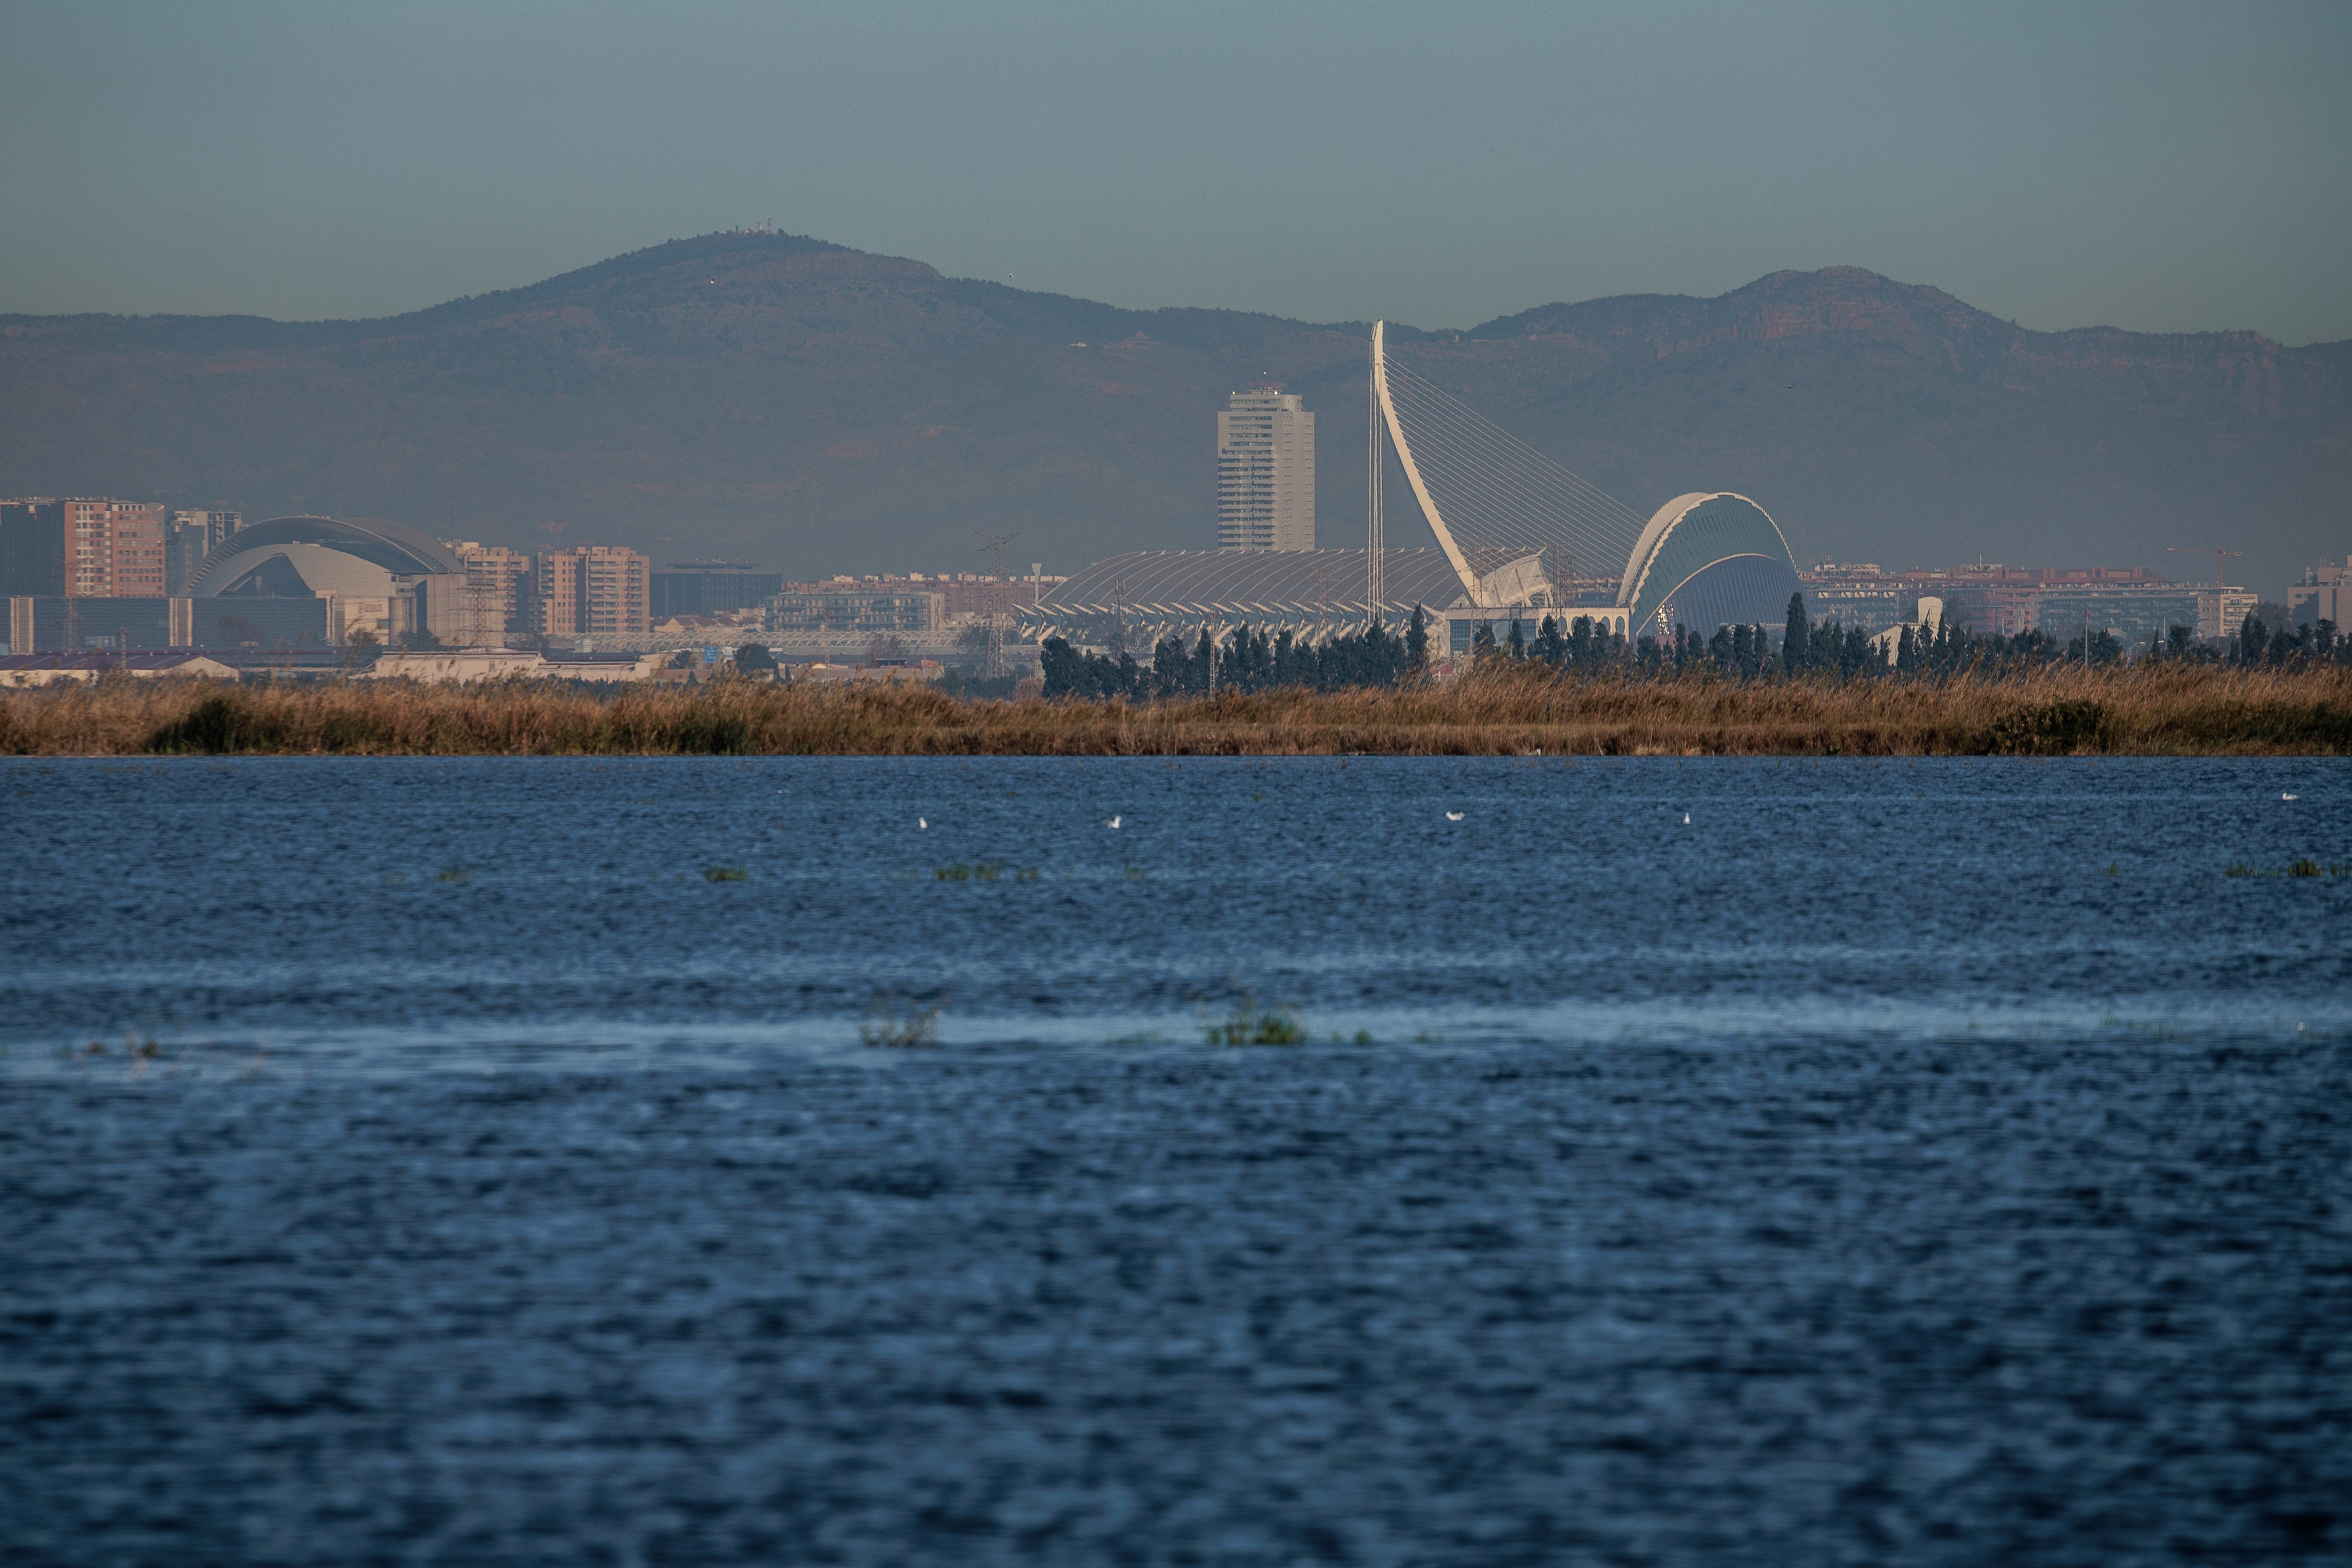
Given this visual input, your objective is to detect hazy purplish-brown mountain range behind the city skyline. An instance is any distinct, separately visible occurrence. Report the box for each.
[0,233,2352,592]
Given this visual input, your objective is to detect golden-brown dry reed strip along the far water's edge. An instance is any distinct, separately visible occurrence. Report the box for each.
[0,665,2352,757]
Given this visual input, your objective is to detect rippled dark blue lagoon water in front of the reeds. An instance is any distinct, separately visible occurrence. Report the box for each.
[0,757,2352,1566]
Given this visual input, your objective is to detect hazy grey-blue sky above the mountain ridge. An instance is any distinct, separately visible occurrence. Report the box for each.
[14,0,2352,343]
